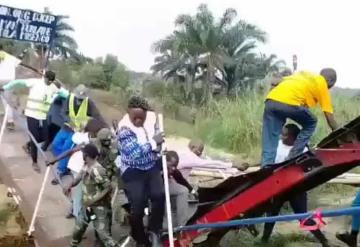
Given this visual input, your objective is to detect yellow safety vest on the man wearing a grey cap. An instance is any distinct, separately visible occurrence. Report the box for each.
[69,94,89,131]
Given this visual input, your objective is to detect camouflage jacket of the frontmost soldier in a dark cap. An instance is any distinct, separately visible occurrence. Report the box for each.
[82,163,111,206]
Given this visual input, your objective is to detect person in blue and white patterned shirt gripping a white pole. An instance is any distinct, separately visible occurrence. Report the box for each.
[117,96,165,246]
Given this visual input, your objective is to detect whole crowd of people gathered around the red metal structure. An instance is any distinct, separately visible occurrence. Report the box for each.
[1,55,360,247]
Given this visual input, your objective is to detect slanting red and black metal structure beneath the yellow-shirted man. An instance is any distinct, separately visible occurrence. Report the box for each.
[167,117,360,247]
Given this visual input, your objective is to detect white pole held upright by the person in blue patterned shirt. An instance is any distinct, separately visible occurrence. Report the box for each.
[159,113,174,247]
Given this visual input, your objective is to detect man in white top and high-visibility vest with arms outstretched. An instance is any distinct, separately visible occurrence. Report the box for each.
[0,71,69,172]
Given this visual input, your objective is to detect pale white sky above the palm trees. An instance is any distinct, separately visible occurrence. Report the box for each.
[0,0,360,88]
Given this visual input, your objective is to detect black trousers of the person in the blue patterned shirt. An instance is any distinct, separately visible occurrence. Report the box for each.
[122,167,165,244]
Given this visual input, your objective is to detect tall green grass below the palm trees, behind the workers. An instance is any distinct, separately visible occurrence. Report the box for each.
[100,86,360,163]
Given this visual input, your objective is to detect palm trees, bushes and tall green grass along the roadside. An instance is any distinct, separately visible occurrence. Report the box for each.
[0,4,360,247]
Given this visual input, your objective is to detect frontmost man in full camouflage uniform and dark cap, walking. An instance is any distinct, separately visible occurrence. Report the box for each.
[65,144,119,247]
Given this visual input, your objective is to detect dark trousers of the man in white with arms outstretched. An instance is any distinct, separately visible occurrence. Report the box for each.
[26,117,47,163]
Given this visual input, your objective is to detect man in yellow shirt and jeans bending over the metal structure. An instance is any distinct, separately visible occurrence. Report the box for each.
[261,68,337,166]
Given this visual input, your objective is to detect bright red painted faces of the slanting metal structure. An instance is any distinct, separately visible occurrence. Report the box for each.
[169,144,360,247]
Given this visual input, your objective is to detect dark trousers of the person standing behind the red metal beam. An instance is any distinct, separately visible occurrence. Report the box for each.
[262,192,327,243]
